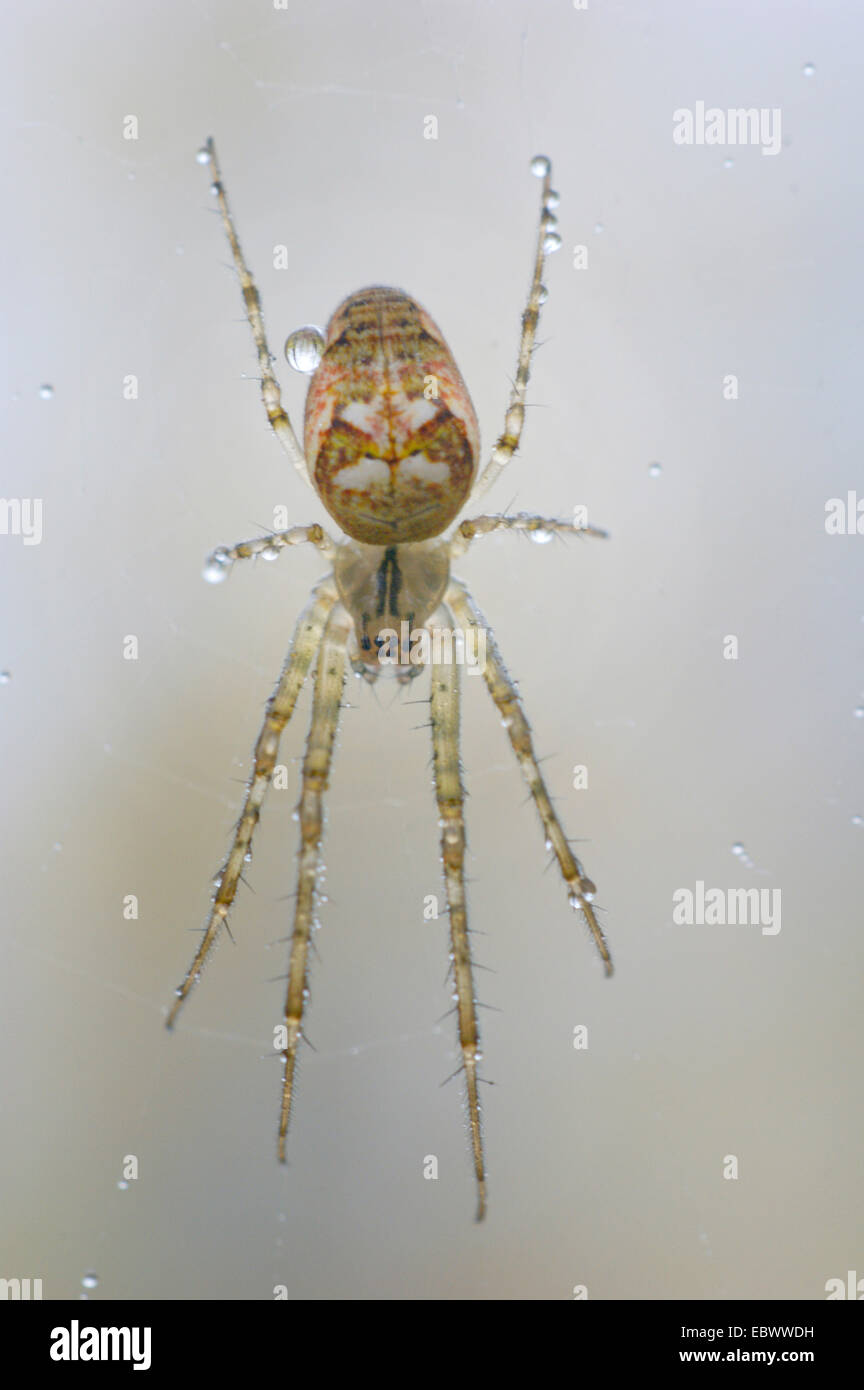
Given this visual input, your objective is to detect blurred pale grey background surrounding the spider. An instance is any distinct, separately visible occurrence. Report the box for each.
[0,0,864,1300]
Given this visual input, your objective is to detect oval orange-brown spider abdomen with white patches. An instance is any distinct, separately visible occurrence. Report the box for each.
[306,285,479,546]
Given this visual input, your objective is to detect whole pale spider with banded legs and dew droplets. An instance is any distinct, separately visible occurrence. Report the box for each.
[167,139,613,1220]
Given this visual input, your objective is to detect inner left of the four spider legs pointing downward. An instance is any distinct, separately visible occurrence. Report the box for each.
[279,605,353,1163]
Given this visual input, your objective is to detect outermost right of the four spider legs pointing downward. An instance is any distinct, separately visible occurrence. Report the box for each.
[446,580,613,976]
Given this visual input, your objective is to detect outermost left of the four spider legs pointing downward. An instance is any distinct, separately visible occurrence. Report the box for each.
[167,580,336,1029]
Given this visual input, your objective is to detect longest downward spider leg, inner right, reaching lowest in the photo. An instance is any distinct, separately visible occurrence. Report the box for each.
[431,607,486,1220]
